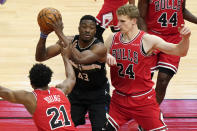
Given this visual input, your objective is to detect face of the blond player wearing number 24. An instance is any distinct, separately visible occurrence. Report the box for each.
[117,15,134,33]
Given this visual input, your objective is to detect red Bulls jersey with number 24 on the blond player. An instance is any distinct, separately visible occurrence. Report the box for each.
[110,31,154,95]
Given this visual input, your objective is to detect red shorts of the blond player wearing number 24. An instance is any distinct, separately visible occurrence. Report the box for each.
[107,89,167,130]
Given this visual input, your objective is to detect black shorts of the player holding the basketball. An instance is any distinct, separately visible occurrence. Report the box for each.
[68,82,109,131]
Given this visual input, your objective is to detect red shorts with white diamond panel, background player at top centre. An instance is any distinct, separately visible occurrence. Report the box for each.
[96,1,127,30]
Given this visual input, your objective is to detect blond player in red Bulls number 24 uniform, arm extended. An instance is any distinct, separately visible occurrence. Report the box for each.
[103,5,191,131]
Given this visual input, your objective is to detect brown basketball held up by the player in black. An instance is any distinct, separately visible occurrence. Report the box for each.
[37,7,62,33]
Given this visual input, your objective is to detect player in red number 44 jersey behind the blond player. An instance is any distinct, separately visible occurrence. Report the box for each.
[138,0,197,104]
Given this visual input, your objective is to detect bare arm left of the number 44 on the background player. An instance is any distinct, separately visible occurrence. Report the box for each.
[138,0,149,31]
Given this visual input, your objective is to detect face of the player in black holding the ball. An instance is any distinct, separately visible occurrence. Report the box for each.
[79,20,96,42]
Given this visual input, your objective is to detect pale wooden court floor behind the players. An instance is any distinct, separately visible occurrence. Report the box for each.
[0,0,197,99]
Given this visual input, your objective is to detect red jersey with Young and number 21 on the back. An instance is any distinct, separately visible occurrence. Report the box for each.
[33,87,76,131]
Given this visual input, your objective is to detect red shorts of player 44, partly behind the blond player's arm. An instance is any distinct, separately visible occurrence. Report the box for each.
[148,32,182,73]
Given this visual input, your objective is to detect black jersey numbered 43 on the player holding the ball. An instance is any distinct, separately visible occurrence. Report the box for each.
[68,35,107,93]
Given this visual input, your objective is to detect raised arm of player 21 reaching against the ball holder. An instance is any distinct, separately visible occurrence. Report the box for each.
[56,47,76,95]
